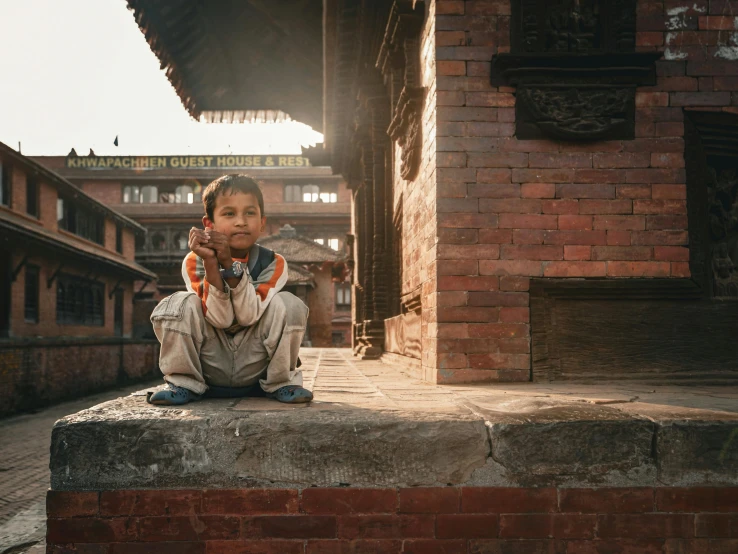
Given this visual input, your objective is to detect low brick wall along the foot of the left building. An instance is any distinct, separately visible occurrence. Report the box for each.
[0,338,160,417]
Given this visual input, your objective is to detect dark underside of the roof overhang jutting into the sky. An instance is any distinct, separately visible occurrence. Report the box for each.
[127,0,323,131]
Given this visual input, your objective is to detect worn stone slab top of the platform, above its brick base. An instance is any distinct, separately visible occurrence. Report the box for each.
[51,349,738,490]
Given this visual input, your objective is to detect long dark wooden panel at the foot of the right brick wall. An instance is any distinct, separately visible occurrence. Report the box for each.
[530,280,738,381]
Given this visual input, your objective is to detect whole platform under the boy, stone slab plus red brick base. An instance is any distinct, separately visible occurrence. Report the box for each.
[47,349,738,554]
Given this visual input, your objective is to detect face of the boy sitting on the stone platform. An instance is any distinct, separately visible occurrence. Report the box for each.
[202,191,266,258]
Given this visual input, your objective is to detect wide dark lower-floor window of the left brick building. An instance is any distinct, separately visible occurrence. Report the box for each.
[56,274,105,327]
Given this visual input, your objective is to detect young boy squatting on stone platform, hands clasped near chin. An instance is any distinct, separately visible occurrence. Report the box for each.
[149,175,313,405]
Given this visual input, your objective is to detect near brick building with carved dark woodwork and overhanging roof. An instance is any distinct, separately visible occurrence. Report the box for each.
[121,0,738,383]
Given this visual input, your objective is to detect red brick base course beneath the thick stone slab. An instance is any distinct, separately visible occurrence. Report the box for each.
[47,487,738,554]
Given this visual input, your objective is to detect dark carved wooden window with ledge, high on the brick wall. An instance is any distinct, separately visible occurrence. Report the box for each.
[491,0,661,140]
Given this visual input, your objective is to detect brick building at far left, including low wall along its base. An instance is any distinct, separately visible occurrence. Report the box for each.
[0,143,157,414]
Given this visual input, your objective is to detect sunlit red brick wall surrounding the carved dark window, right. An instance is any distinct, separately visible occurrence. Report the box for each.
[424,0,738,383]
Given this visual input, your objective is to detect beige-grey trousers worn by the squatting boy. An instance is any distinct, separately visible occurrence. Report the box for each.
[151,292,308,394]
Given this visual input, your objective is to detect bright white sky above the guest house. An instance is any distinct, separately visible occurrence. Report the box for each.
[0,0,323,155]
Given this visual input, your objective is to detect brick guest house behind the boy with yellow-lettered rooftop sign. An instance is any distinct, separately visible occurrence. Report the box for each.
[34,155,351,346]
